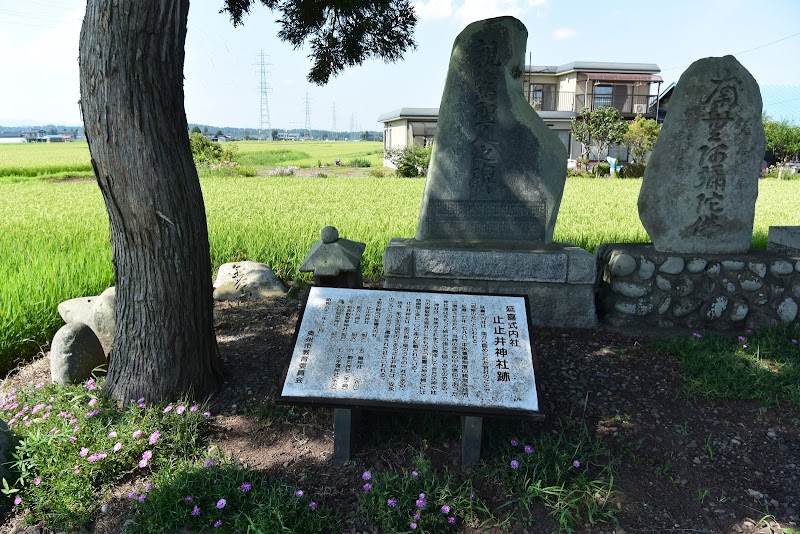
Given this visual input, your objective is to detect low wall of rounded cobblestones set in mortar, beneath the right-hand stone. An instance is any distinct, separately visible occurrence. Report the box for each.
[596,244,800,330]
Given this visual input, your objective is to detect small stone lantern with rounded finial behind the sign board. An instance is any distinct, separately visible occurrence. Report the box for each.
[300,226,367,289]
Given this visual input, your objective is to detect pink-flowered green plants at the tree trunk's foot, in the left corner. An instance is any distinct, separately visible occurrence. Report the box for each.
[0,380,211,532]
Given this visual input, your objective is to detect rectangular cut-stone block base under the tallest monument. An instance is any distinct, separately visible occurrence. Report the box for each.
[383,238,597,328]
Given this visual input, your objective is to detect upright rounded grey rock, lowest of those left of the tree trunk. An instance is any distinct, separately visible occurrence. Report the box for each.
[50,323,106,385]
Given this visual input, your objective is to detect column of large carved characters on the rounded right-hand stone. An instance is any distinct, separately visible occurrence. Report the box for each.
[687,77,739,236]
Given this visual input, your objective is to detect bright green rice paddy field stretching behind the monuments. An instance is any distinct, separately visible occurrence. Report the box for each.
[0,142,800,370]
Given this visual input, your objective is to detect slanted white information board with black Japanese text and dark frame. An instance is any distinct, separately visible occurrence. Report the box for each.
[280,287,539,415]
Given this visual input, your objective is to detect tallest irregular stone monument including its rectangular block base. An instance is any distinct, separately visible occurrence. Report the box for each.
[383,17,597,327]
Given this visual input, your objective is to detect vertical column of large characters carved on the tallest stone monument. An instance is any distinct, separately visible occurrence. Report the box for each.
[469,39,502,194]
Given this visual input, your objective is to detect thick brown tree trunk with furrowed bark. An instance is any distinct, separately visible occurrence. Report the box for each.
[79,0,221,401]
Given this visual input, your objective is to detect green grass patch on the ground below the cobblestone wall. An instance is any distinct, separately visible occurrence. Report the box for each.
[652,325,800,406]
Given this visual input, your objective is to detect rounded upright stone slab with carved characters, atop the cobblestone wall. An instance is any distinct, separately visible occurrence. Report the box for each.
[639,56,765,253]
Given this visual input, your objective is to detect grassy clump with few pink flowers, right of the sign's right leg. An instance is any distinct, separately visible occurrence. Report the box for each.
[482,419,616,532]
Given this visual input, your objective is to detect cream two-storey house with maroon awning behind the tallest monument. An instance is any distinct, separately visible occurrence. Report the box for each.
[378,61,663,165]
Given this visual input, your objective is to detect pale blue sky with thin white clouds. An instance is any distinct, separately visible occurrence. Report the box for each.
[0,0,800,131]
